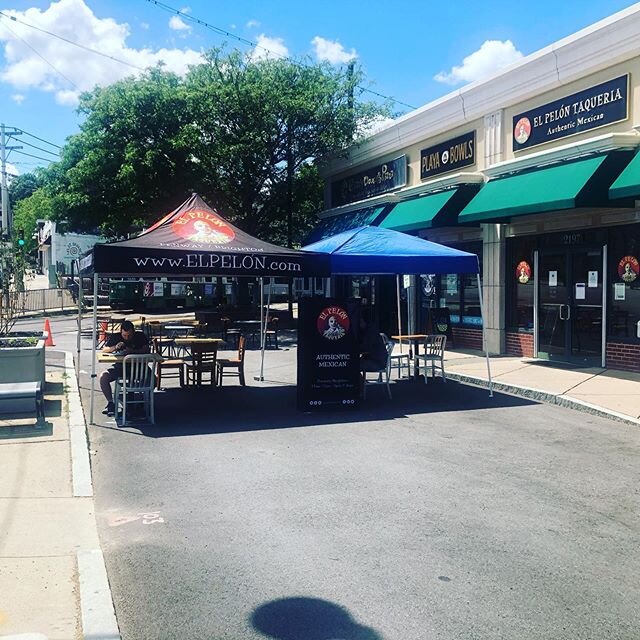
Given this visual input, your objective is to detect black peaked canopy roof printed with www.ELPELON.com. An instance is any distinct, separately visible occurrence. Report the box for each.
[91,193,331,277]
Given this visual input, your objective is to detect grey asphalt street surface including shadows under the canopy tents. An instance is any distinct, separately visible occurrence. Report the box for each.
[15,320,640,640]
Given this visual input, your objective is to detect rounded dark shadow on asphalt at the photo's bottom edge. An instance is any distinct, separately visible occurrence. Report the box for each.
[251,598,382,640]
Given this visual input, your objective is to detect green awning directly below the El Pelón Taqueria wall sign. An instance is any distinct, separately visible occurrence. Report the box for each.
[458,154,608,223]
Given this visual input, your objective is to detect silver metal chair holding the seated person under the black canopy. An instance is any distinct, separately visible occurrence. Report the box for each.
[115,353,158,426]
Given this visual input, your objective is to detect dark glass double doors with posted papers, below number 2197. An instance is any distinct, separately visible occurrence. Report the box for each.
[537,246,604,366]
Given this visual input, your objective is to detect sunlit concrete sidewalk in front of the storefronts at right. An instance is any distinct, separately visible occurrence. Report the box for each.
[445,351,640,426]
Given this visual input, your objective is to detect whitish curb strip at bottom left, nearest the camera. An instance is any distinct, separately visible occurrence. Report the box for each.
[78,549,121,640]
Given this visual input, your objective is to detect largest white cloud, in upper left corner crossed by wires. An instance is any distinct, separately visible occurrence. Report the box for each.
[0,0,202,105]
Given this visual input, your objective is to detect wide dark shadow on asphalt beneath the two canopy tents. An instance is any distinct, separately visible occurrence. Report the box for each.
[119,381,539,438]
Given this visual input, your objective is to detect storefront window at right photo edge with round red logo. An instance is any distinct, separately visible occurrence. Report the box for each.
[607,225,640,341]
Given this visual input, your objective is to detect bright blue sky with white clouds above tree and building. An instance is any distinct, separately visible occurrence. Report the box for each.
[0,0,635,173]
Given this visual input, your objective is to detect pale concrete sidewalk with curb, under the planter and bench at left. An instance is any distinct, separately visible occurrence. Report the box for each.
[0,351,120,640]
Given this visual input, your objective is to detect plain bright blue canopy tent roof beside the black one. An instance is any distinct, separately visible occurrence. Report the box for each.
[303,227,479,275]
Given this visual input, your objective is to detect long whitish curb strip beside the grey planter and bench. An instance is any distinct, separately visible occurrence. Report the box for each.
[64,351,93,497]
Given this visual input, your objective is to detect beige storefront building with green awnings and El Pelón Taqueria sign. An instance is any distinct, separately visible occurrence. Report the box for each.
[320,5,640,371]
